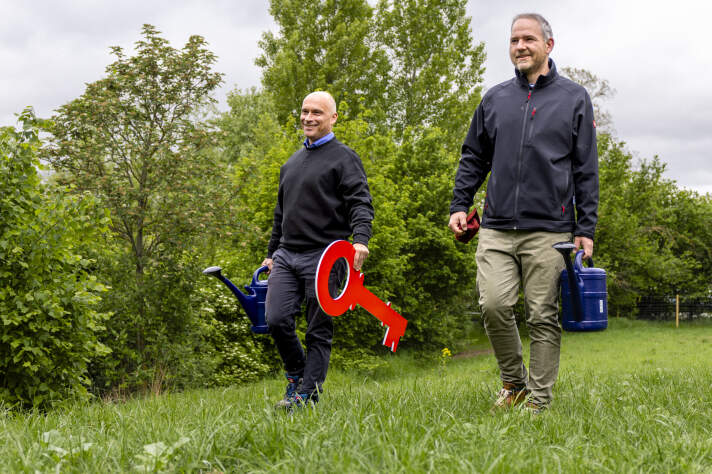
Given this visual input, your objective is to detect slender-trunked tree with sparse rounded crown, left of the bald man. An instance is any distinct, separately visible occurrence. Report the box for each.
[45,25,234,392]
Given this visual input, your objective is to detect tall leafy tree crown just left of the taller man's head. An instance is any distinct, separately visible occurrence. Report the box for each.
[376,0,485,139]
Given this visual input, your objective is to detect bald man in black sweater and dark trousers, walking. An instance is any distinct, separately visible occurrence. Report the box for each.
[262,91,373,409]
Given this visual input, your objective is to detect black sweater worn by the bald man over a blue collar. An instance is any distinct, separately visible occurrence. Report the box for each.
[267,138,373,258]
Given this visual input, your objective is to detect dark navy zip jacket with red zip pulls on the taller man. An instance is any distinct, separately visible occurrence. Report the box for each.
[450,59,598,239]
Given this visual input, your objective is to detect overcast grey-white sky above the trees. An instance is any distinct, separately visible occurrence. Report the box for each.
[0,0,712,193]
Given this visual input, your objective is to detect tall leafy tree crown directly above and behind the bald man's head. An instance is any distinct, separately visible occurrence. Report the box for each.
[256,0,387,123]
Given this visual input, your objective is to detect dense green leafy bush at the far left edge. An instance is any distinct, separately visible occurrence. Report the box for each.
[0,109,109,406]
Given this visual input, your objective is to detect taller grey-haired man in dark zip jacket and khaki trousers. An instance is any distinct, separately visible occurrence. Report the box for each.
[449,14,598,412]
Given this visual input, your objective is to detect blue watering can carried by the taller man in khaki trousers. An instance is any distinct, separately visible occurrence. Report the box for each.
[554,242,608,331]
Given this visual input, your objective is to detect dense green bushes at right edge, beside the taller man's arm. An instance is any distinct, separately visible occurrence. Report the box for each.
[595,134,712,314]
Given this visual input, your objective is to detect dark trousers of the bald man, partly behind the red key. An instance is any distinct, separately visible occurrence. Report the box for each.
[265,248,346,393]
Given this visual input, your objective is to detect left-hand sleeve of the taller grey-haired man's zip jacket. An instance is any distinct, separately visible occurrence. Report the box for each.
[450,103,494,214]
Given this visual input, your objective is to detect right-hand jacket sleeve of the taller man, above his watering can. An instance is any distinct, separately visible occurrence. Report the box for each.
[572,90,598,239]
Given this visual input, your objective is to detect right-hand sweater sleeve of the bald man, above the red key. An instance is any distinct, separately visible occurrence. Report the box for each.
[339,151,374,246]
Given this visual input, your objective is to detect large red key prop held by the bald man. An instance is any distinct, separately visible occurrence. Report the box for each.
[316,240,408,352]
